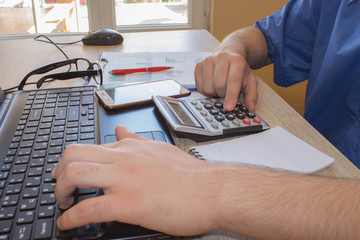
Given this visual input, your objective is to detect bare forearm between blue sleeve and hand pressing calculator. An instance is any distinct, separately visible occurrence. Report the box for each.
[214,27,271,69]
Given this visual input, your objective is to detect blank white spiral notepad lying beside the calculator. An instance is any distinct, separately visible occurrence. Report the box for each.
[189,126,334,174]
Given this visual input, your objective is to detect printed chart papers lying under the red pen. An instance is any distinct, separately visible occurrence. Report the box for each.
[100,52,211,88]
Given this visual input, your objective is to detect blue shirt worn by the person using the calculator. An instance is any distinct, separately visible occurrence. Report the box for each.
[255,0,360,168]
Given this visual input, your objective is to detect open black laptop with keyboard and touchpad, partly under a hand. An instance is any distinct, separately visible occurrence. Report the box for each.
[0,86,173,240]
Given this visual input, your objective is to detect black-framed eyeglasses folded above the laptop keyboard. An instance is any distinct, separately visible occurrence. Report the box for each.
[18,58,103,90]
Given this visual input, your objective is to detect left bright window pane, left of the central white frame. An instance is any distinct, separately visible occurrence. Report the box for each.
[0,0,89,34]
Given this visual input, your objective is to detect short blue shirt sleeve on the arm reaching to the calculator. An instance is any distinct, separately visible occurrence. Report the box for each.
[255,0,322,87]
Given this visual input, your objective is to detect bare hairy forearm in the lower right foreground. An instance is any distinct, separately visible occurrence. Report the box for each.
[212,167,360,240]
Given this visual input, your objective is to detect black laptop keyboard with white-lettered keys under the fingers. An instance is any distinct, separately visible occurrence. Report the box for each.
[0,87,104,240]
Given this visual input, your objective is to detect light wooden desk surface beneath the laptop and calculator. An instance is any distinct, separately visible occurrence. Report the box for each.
[0,30,360,238]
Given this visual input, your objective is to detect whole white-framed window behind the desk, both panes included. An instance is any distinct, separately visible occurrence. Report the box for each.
[0,0,209,35]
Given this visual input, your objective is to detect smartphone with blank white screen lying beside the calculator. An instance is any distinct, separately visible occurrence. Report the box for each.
[95,79,190,110]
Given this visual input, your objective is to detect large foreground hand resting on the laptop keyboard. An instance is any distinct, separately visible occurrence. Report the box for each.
[52,126,218,235]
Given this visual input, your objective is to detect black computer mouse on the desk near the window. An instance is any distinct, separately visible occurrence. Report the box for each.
[81,29,124,46]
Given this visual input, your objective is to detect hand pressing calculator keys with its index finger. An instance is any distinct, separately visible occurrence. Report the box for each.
[195,52,258,111]
